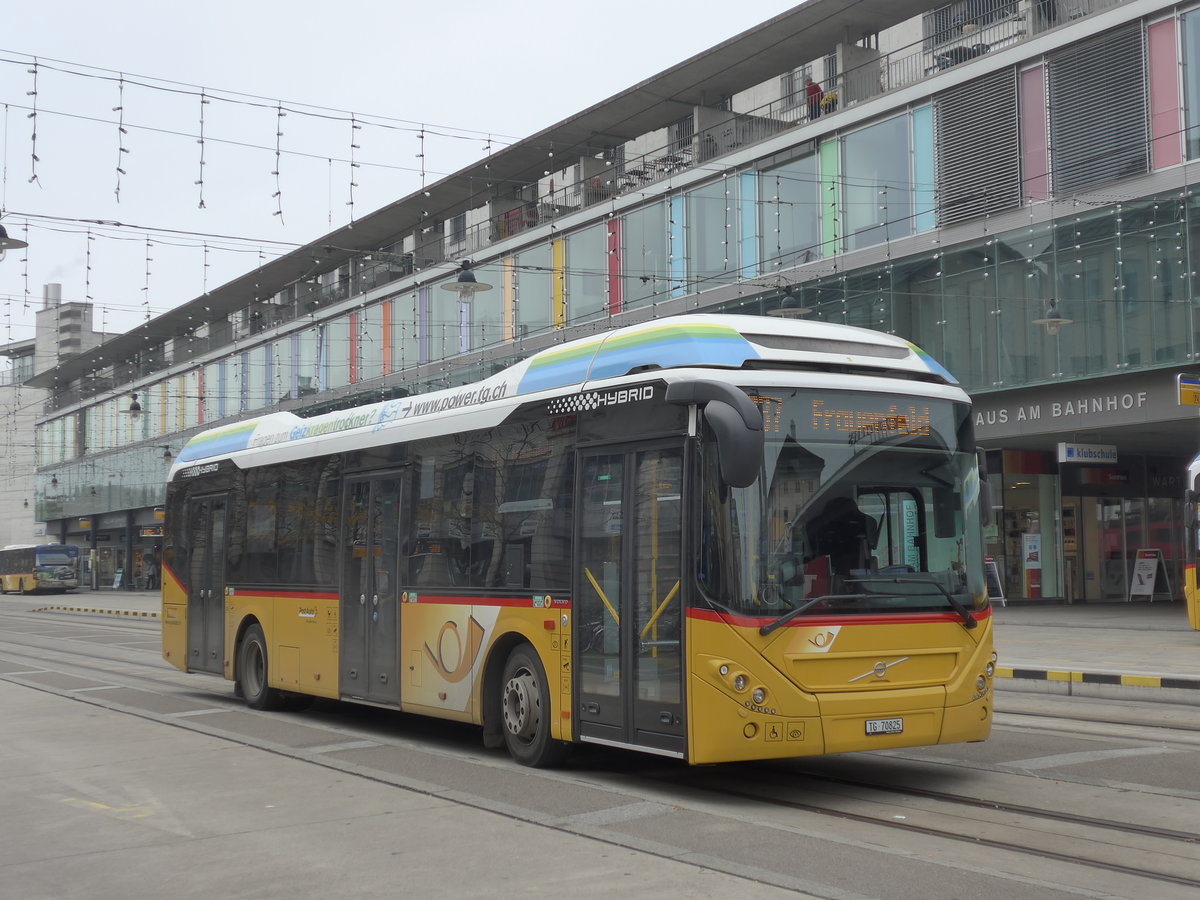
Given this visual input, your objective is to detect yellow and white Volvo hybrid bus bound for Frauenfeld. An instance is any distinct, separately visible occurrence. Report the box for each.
[162,316,996,766]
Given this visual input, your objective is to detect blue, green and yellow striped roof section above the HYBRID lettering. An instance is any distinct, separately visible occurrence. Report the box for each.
[517,322,758,394]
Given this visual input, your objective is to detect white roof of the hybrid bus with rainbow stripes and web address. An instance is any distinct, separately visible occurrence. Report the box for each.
[172,314,966,476]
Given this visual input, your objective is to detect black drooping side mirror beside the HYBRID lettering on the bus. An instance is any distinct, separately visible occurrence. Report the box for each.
[667,380,766,487]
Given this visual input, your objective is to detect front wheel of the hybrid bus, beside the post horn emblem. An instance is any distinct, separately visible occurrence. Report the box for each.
[499,644,566,768]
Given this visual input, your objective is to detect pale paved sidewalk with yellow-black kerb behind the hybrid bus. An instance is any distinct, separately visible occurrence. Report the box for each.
[25,590,1200,704]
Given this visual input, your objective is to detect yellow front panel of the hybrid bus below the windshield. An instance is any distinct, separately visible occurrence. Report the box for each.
[688,616,992,763]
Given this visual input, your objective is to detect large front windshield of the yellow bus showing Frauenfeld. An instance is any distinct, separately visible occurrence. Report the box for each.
[697,388,988,617]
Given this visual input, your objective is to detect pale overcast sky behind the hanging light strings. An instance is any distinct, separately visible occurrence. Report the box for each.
[0,0,797,352]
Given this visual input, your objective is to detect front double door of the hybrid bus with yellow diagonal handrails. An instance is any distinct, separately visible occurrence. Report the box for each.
[574,445,686,756]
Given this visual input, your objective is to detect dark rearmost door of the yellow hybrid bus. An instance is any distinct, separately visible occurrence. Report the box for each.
[187,494,228,674]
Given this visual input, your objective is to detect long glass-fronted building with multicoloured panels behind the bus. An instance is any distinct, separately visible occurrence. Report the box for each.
[28,0,1200,601]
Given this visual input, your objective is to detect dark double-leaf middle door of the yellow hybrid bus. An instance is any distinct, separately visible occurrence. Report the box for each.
[338,476,401,706]
